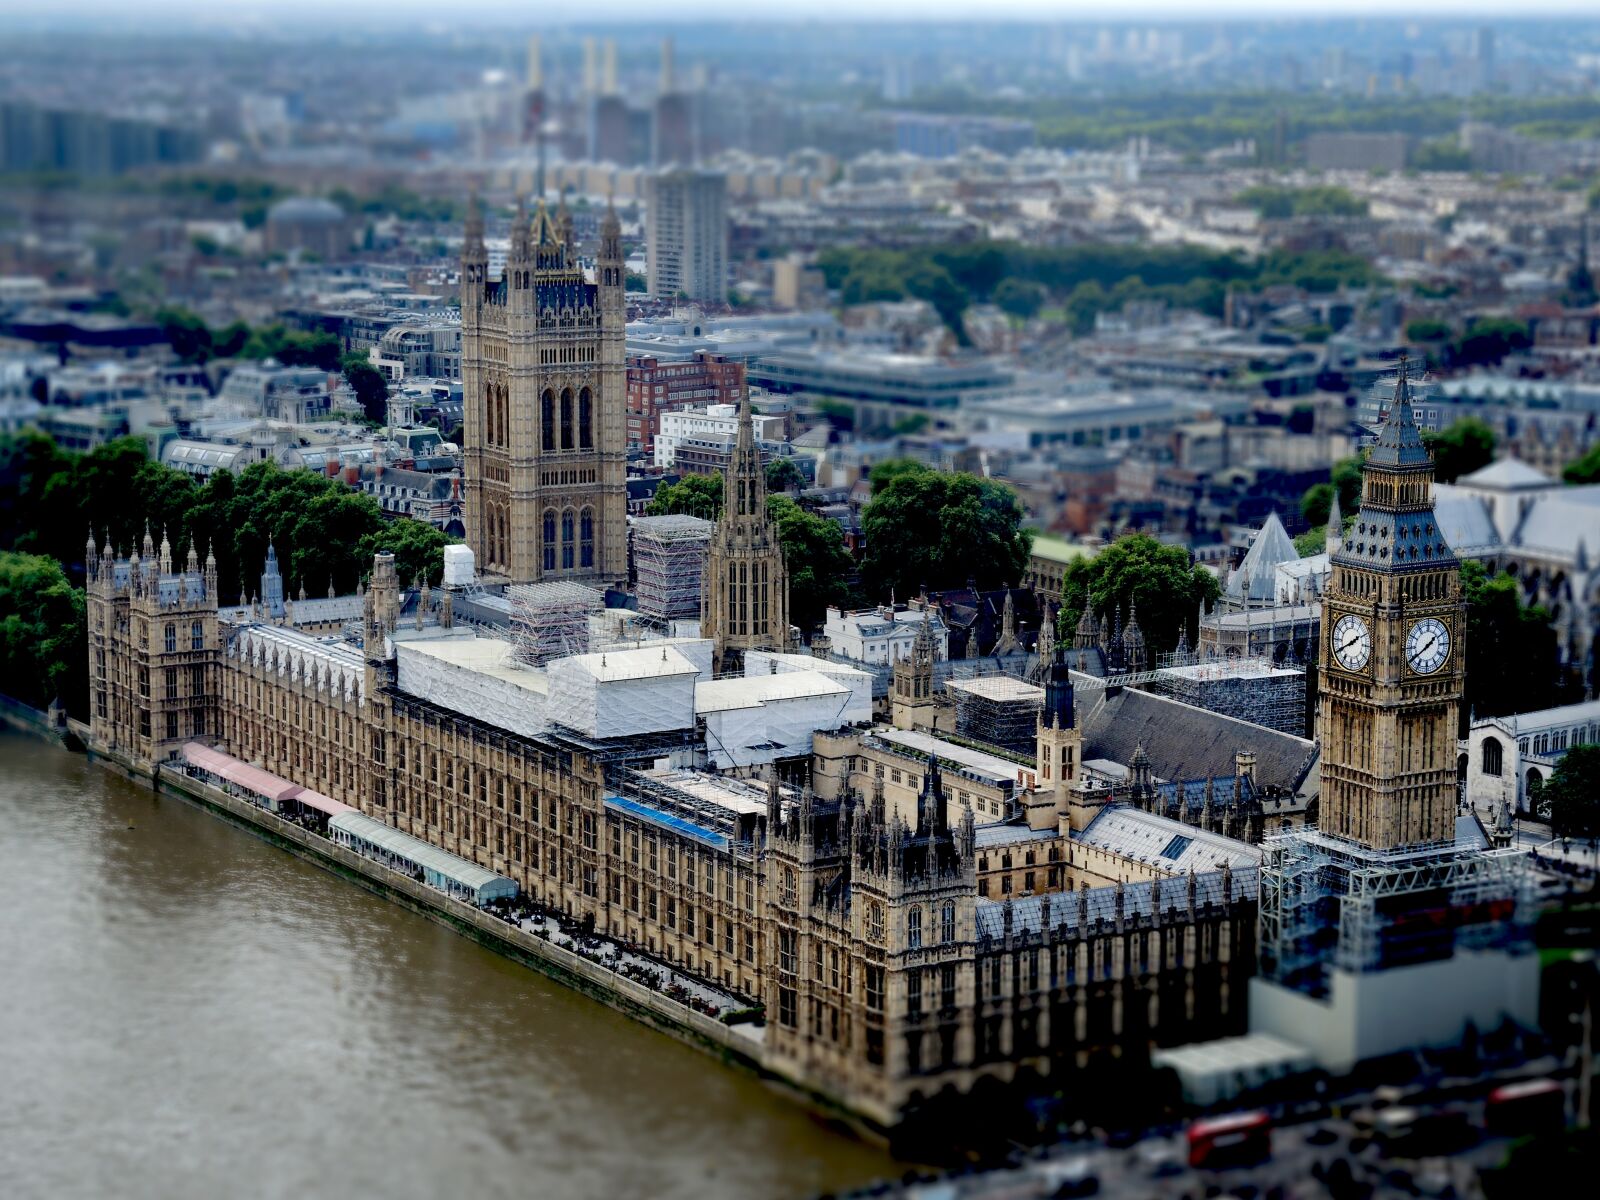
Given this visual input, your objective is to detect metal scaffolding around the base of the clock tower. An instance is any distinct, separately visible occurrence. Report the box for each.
[1259,829,1533,997]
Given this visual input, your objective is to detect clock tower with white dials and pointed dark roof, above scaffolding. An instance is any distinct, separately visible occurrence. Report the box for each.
[1317,360,1464,851]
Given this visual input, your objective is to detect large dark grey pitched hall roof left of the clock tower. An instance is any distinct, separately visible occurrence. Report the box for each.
[1078,688,1317,792]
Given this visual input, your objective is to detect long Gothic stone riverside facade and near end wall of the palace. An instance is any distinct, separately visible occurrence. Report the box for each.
[91,555,1254,1126]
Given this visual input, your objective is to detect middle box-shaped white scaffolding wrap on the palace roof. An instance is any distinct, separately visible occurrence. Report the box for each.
[547,643,699,738]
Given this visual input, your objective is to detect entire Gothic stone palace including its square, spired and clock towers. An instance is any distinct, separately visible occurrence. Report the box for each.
[86,206,1529,1126]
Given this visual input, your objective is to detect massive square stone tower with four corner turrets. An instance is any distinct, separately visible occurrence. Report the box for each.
[461,192,627,586]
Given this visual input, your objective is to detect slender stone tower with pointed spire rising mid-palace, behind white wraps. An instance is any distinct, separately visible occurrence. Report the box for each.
[701,400,789,674]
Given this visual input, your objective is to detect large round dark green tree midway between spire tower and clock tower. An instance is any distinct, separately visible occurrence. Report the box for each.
[861,466,1032,597]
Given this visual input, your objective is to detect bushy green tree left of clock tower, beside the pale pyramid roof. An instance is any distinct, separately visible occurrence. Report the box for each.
[1056,533,1222,654]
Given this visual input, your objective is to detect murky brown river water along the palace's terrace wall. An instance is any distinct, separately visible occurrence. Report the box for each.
[0,731,898,1200]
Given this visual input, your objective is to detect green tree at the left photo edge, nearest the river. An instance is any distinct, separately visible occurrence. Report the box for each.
[0,552,88,717]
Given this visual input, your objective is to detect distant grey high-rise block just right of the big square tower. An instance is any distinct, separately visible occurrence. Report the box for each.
[645,170,728,304]
